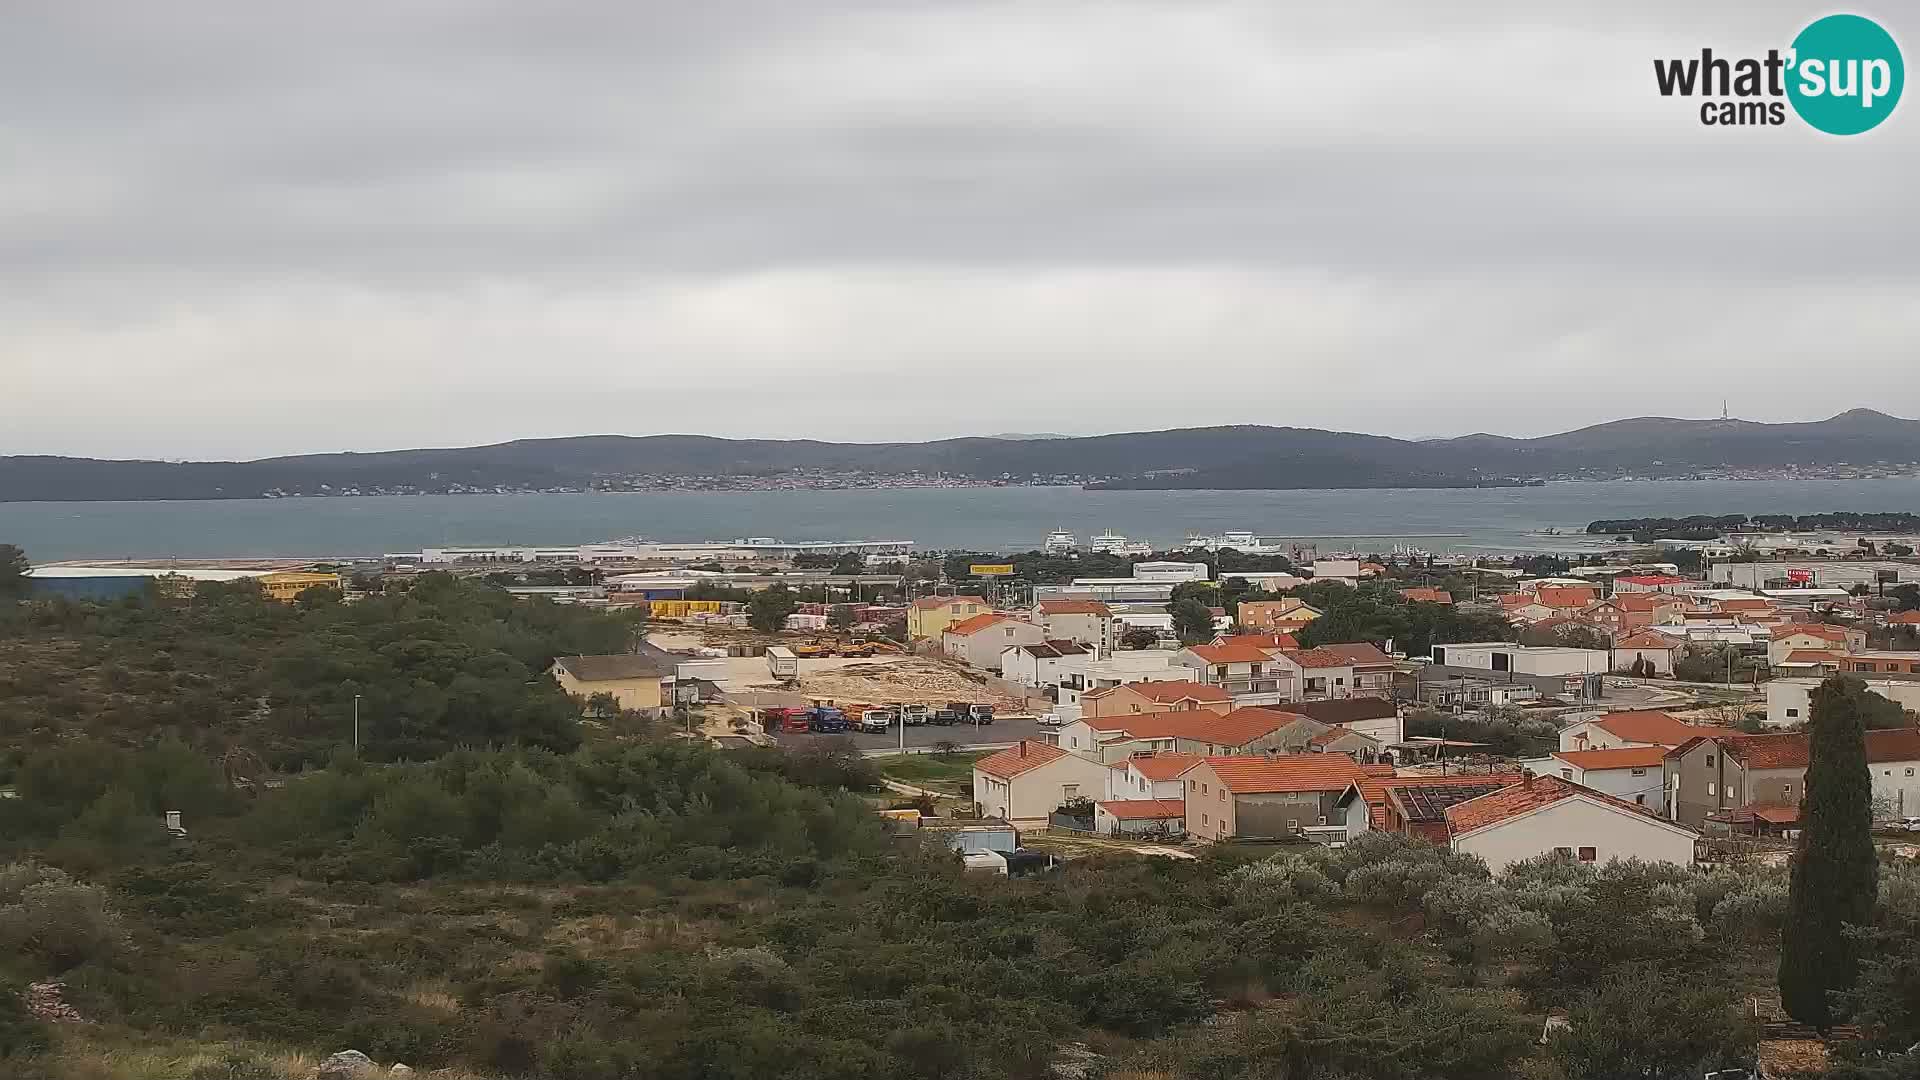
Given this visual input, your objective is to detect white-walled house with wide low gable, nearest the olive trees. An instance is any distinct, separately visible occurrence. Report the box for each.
[1446,776,1697,874]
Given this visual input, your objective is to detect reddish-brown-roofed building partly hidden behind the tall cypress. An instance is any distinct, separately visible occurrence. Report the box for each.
[1667,728,1920,824]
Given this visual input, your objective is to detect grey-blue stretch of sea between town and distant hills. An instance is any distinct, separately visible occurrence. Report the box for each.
[0,477,1920,561]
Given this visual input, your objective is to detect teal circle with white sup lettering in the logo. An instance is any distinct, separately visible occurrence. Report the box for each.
[1788,15,1907,135]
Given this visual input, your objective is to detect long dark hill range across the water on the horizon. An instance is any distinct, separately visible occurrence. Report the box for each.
[0,409,1920,502]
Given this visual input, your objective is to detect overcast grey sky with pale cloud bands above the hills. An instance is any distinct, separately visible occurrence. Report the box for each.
[0,0,1920,457]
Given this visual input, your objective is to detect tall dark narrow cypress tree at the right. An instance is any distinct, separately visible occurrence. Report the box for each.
[1780,675,1880,1030]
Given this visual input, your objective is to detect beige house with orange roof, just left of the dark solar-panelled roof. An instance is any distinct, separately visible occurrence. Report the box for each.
[1185,753,1367,840]
